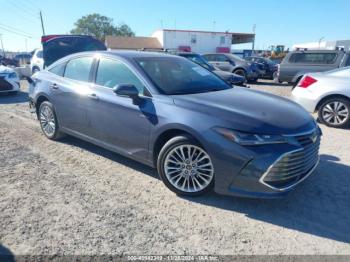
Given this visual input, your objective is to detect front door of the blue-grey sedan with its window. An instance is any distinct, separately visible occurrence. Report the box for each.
[88,57,156,161]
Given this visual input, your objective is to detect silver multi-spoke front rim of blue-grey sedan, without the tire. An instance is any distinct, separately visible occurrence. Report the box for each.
[164,145,214,193]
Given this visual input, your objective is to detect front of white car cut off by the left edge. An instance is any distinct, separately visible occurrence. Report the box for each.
[0,65,20,93]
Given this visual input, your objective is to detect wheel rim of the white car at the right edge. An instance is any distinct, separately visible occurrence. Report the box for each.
[322,101,349,125]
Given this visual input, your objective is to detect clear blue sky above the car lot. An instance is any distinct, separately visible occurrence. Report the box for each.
[0,0,350,51]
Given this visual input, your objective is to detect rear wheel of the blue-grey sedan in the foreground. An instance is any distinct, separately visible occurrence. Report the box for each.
[38,101,63,140]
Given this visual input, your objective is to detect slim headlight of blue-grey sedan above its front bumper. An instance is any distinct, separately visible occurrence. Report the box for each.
[214,127,287,146]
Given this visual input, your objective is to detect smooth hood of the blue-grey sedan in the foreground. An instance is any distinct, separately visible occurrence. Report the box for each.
[173,87,315,135]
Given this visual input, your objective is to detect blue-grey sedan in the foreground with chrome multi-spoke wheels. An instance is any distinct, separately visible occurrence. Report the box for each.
[29,51,321,197]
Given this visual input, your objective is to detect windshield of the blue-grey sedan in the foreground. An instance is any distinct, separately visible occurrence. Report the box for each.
[136,57,232,95]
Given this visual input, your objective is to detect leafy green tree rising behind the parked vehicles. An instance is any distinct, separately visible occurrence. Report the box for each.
[71,14,135,41]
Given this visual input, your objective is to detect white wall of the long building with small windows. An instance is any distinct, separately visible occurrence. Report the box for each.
[152,31,232,53]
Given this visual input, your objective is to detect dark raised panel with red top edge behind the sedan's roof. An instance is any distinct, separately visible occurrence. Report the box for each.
[41,35,107,67]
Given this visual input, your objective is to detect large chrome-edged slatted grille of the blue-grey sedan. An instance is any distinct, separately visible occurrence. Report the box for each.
[263,131,321,189]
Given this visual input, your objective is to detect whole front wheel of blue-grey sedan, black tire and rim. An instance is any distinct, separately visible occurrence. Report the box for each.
[157,136,214,196]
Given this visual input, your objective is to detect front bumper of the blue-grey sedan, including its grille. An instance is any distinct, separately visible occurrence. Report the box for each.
[206,127,322,198]
